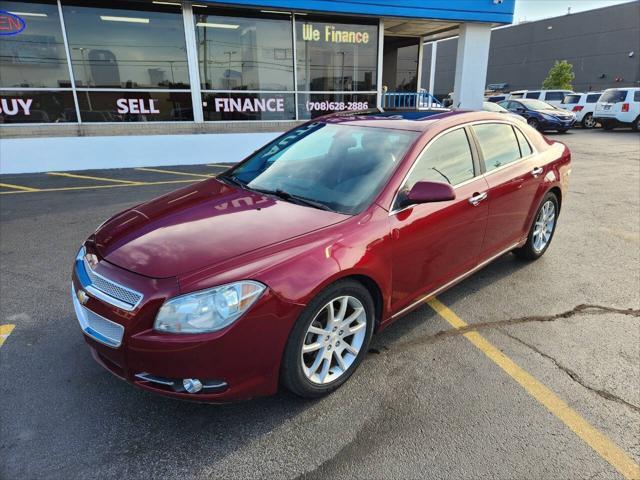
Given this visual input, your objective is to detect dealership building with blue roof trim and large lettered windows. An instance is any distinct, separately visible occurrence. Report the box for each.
[0,0,515,173]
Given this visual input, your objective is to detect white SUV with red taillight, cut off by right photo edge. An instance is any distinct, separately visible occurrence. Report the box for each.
[593,88,640,132]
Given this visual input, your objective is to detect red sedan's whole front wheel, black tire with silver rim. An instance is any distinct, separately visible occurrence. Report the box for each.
[280,280,376,398]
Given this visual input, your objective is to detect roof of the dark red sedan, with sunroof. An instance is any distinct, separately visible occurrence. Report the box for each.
[316,110,520,132]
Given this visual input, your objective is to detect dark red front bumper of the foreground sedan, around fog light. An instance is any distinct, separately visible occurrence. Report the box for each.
[72,244,302,402]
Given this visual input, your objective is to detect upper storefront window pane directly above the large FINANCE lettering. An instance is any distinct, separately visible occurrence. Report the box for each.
[194,6,293,91]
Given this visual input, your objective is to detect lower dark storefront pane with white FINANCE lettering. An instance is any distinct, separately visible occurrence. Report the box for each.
[202,92,296,120]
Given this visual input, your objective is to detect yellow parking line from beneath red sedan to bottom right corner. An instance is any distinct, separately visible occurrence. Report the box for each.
[427,298,640,480]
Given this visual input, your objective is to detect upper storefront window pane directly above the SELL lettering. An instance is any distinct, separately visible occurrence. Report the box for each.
[63,2,189,89]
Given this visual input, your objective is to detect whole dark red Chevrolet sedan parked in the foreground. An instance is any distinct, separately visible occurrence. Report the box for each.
[72,112,571,402]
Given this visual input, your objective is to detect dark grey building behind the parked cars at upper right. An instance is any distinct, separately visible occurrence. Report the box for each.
[422,1,640,98]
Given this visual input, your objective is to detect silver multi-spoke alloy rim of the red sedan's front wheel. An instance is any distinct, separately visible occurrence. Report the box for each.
[300,295,367,385]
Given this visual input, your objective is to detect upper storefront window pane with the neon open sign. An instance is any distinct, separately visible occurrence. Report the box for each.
[0,1,71,88]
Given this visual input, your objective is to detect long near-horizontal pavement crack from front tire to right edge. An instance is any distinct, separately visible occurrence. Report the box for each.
[382,304,640,353]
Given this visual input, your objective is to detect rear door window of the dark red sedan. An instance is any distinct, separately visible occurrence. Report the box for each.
[473,123,520,172]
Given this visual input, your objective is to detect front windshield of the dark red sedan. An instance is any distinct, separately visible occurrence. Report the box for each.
[220,122,419,214]
